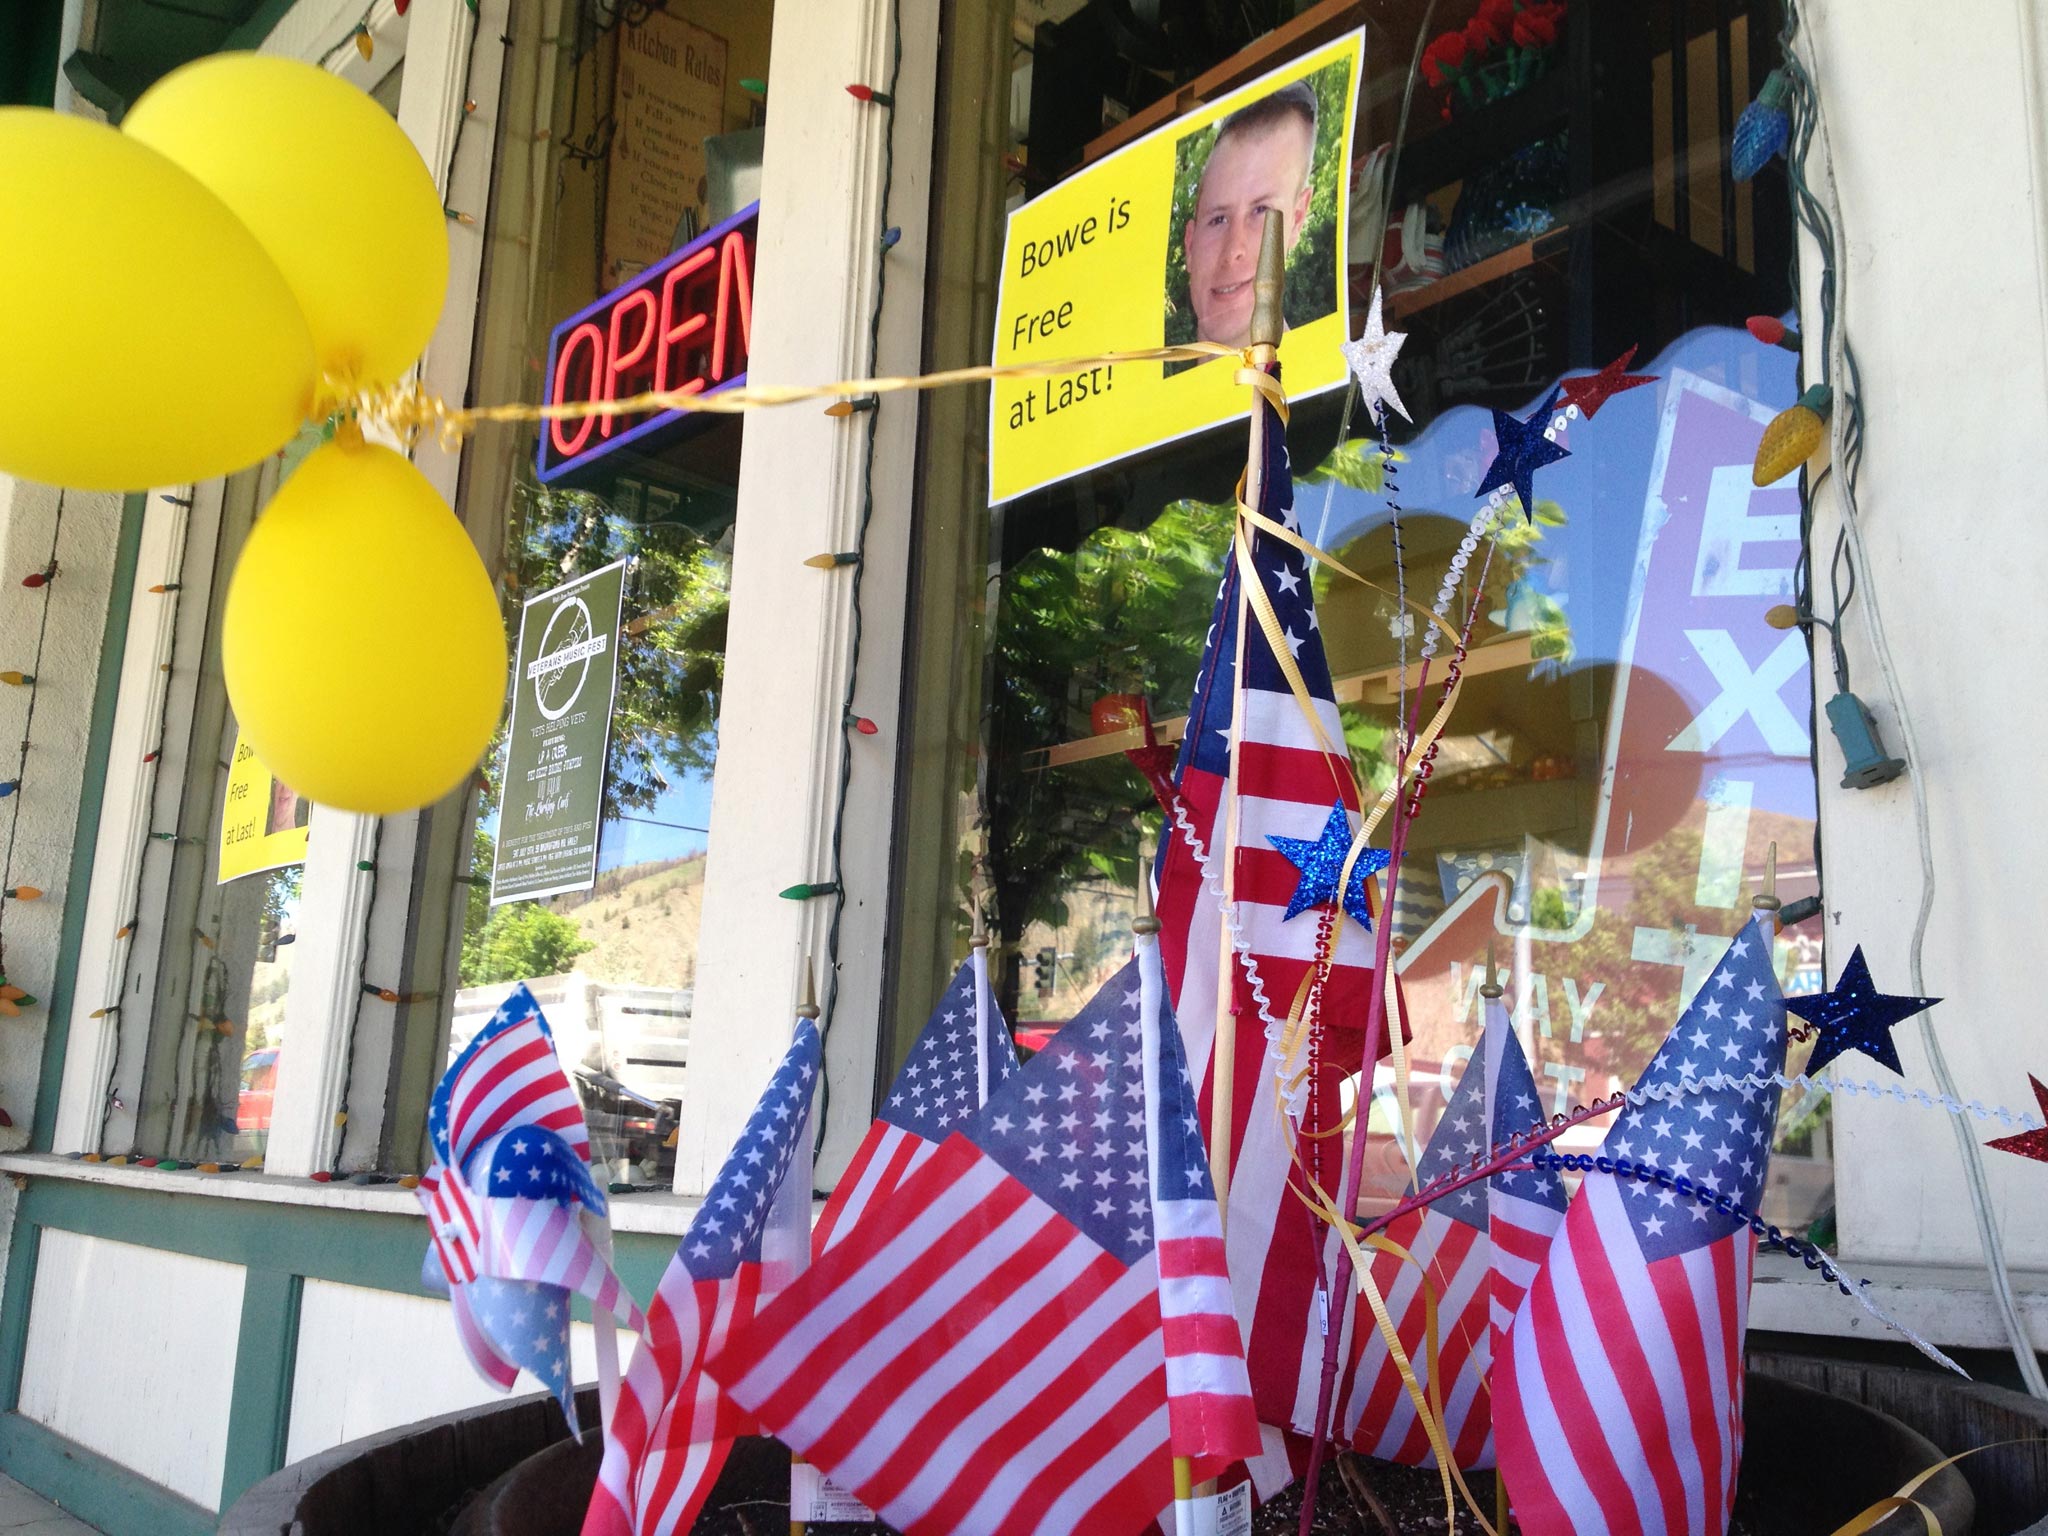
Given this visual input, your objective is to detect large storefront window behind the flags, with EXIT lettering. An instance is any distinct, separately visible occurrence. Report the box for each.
[897,4,1833,1235]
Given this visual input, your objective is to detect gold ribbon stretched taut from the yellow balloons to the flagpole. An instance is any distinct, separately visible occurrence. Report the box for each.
[354,342,1236,446]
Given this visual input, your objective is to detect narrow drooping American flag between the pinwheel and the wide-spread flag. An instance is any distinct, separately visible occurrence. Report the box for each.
[584,1018,821,1536]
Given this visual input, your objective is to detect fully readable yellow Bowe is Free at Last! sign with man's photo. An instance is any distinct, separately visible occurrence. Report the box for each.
[989,31,1364,502]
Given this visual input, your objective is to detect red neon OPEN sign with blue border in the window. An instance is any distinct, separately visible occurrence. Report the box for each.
[539,203,760,481]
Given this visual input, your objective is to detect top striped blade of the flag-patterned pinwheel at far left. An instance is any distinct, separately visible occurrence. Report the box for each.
[426,983,590,1169]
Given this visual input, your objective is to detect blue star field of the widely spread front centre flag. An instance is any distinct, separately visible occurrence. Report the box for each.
[961,961,1155,1264]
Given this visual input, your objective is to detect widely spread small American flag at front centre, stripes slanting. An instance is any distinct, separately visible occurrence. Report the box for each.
[711,963,1257,1536]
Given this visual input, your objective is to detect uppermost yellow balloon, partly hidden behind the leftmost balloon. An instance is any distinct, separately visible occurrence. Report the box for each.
[121,53,449,393]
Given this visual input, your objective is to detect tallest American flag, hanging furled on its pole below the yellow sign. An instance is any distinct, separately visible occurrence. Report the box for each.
[1159,378,1393,1427]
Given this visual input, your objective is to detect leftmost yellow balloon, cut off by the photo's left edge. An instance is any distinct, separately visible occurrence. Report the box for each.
[0,106,313,492]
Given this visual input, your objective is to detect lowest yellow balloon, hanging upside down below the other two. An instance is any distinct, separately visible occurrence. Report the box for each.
[221,428,508,815]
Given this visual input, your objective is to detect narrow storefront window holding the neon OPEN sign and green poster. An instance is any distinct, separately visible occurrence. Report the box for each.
[401,0,772,1186]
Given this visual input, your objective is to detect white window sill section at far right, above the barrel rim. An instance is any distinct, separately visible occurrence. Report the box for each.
[1749,1253,2048,1350]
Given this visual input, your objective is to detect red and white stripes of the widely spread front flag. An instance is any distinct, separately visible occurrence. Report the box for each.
[711,1135,1217,1536]
